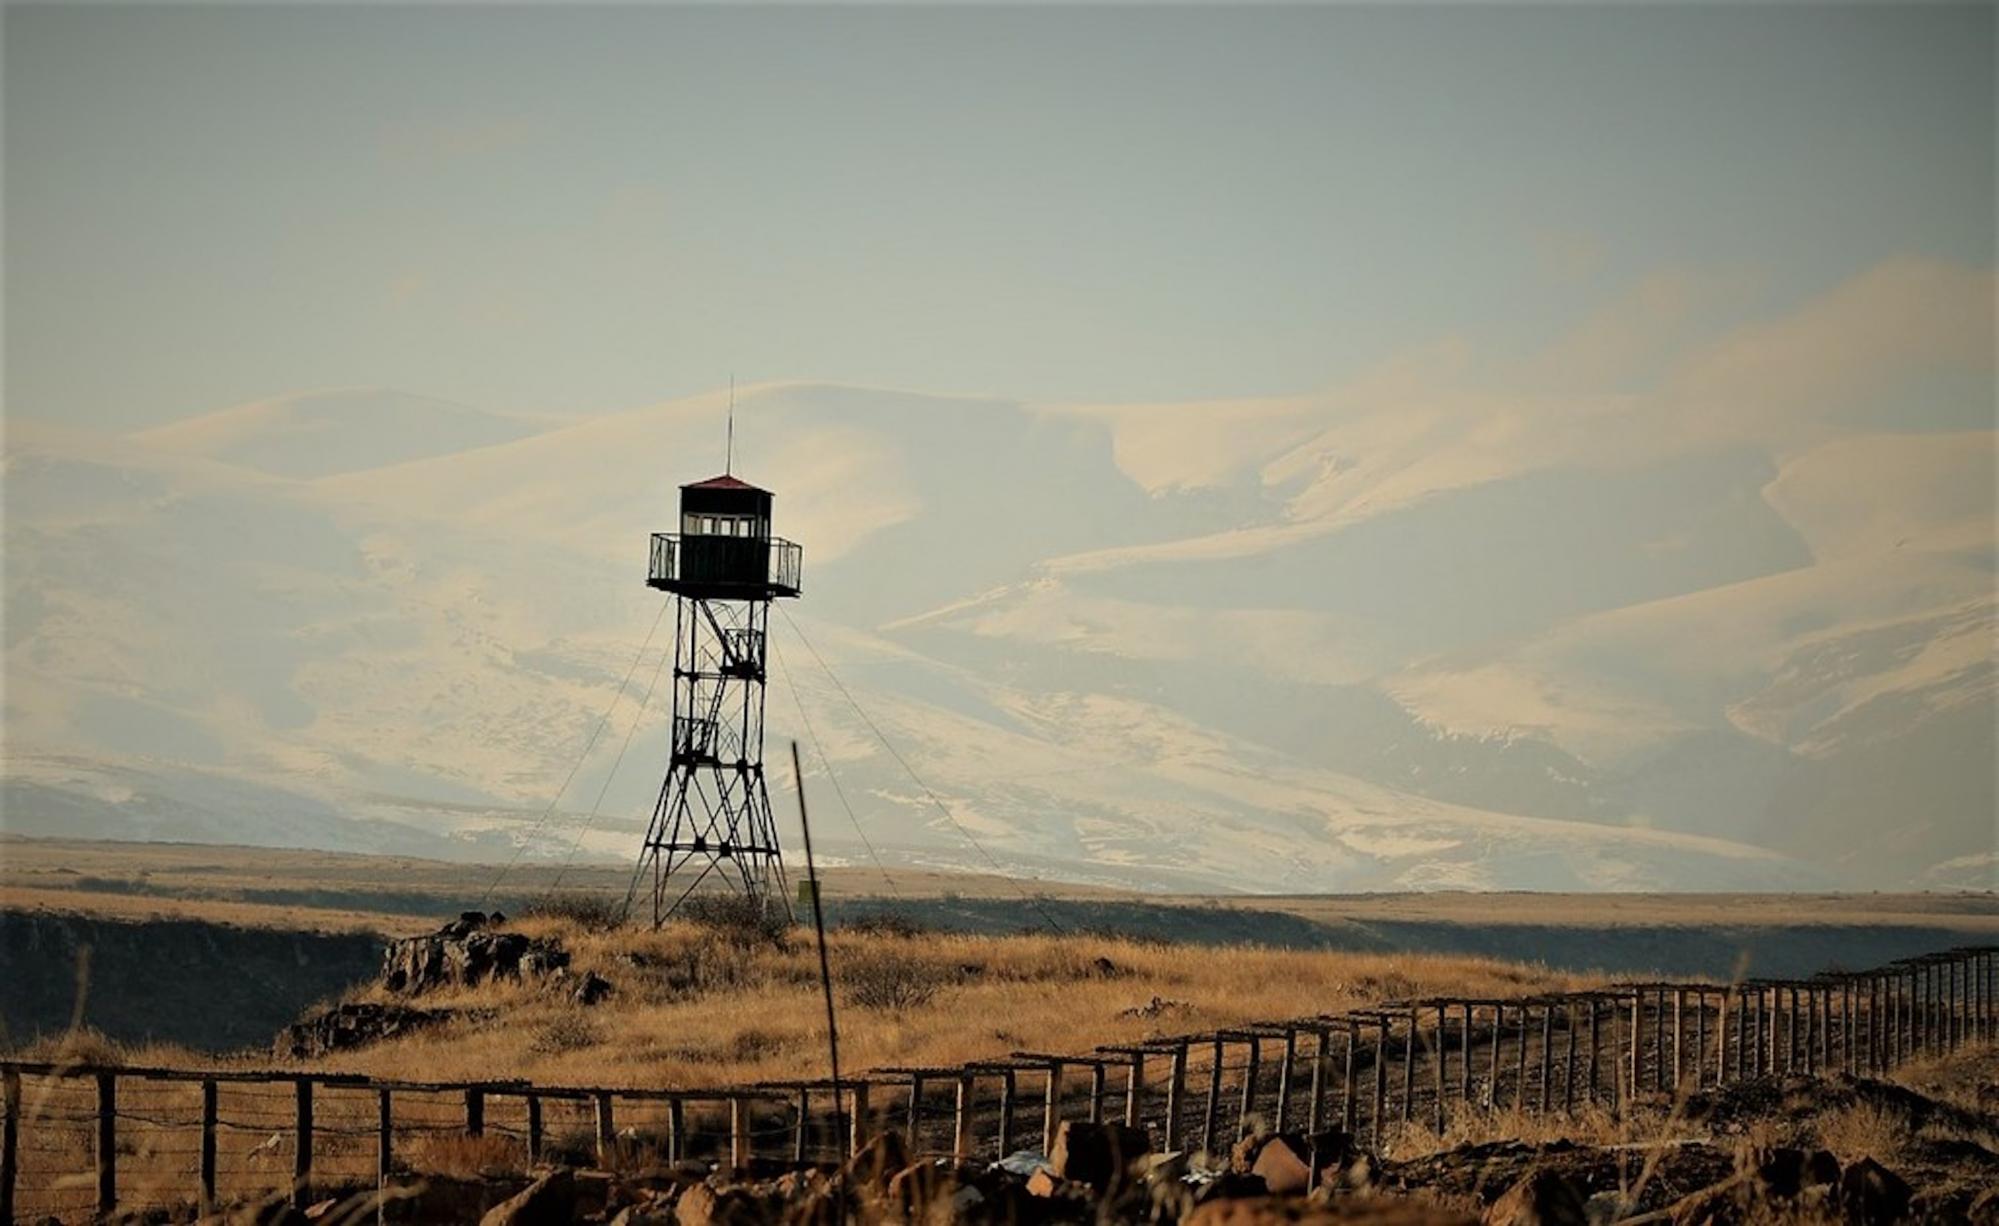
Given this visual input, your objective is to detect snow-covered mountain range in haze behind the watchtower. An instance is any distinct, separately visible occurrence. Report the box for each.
[4,266,1999,890]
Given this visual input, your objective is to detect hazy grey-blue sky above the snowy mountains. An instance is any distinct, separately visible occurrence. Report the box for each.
[4,6,1995,428]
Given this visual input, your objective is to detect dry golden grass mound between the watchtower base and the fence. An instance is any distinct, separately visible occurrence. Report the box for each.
[277,916,1587,1088]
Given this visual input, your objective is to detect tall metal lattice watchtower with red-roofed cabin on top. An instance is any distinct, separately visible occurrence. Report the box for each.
[640,476,804,926]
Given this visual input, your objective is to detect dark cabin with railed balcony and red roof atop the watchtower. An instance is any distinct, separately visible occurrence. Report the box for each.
[646,476,804,600]
